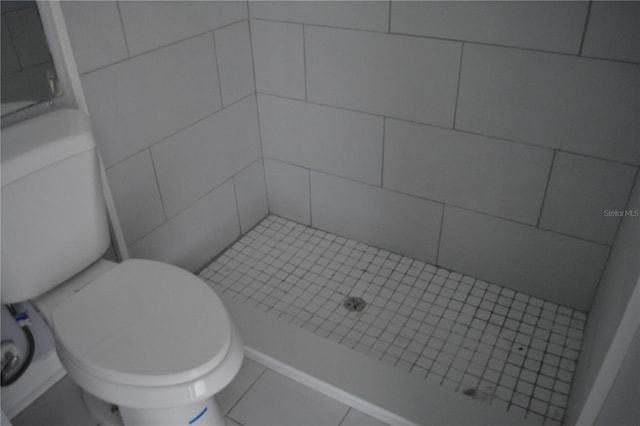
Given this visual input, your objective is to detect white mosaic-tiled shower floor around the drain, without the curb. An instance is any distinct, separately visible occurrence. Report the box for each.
[200,216,586,425]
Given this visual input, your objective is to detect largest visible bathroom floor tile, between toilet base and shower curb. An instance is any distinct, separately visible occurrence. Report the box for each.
[229,370,349,426]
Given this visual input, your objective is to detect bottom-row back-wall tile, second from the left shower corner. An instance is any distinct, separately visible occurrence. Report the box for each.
[311,171,442,262]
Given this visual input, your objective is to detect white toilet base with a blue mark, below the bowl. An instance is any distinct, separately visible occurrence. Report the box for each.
[119,396,224,426]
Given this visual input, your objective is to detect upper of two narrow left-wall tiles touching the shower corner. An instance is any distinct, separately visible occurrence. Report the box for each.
[213,21,255,106]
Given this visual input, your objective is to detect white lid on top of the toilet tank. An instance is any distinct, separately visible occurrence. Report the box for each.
[0,108,95,187]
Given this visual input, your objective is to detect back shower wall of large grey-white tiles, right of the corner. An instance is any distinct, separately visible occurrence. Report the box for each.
[249,1,640,310]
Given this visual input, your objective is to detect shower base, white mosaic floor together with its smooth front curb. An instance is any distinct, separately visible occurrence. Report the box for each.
[200,216,586,425]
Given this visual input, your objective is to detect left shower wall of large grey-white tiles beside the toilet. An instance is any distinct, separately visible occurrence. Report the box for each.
[62,1,268,271]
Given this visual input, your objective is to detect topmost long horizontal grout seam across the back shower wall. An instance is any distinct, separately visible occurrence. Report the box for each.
[250,17,640,65]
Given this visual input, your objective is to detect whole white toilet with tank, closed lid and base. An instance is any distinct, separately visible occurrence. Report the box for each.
[1,109,243,426]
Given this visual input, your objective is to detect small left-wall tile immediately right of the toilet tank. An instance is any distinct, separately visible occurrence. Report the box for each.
[107,149,165,244]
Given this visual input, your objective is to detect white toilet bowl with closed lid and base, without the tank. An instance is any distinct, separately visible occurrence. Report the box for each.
[46,259,243,425]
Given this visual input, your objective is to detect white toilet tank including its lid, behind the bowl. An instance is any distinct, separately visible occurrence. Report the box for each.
[0,109,110,304]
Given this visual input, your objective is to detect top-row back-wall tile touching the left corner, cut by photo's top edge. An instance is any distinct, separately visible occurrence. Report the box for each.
[249,1,389,32]
